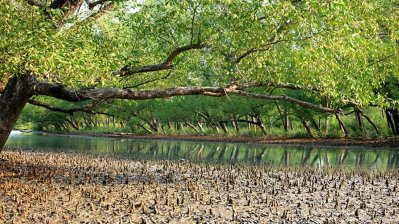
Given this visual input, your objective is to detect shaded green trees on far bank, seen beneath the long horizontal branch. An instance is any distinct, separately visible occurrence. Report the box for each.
[18,93,392,137]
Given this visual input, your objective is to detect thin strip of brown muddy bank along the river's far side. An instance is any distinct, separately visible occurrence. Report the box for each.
[39,132,399,149]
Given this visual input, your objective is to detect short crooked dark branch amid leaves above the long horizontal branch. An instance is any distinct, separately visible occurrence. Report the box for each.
[113,43,205,77]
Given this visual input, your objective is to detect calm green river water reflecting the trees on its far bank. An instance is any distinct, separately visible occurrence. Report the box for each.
[6,132,399,170]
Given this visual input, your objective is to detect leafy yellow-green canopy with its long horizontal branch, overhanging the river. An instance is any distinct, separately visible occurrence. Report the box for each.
[0,0,399,150]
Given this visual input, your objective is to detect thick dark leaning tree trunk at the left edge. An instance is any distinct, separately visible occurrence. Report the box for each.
[0,75,33,151]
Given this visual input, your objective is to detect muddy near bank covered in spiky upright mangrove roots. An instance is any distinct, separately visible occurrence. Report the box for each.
[0,151,399,223]
